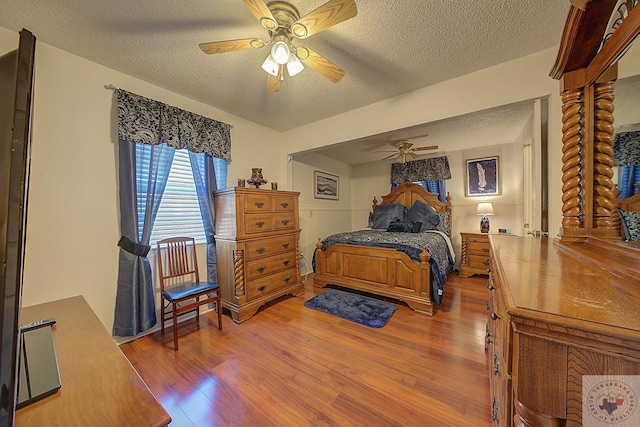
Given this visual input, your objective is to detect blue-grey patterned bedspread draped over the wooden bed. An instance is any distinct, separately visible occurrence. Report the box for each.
[313,230,454,304]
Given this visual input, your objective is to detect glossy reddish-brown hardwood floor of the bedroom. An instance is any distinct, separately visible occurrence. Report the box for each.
[120,274,491,427]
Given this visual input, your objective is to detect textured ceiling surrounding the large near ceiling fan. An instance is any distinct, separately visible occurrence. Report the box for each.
[0,0,570,135]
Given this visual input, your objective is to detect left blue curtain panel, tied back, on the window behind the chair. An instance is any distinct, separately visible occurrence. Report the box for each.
[113,140,175,336]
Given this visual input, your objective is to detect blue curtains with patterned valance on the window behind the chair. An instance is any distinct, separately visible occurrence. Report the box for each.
[113,89,231,336]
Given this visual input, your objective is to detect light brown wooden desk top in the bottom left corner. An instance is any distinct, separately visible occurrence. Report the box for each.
[15,296,171,427]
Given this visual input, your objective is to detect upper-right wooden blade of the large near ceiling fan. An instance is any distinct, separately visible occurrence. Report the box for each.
[292,0,358,39]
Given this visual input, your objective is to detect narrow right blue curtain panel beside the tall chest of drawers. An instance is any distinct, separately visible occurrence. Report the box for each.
[189,151,218,283]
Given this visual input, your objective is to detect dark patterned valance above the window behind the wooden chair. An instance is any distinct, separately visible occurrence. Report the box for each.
[116,89,231,161]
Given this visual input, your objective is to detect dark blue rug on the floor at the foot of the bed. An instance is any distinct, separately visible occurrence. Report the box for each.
[304,289,398,328]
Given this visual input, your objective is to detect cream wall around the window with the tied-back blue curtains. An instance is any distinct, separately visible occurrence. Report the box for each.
[0,28,286,332]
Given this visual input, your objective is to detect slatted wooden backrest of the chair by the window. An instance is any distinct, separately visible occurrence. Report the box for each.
[156,237,200,291]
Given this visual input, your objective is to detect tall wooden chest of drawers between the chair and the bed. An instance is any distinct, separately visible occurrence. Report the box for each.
[214,187,304,323]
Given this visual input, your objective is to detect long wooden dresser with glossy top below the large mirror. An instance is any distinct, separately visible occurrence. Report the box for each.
[486,235,640,427]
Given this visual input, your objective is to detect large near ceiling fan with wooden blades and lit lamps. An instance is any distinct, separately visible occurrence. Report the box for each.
[200,0,358,92]
